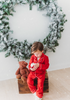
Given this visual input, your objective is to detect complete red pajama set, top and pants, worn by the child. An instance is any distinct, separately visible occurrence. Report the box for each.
[27,53,49,98]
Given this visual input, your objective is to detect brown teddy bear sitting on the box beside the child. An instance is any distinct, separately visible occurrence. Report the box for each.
[15,61,29,82]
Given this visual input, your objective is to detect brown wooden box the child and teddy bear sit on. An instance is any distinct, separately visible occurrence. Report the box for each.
[18,71,49,94]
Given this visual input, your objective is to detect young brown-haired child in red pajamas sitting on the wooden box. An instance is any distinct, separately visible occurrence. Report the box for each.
[27,42,49,100]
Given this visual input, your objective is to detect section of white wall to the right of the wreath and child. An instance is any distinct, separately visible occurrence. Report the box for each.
[47,0,70,71]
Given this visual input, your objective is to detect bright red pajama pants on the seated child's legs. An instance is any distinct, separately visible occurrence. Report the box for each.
[27,74,45,98]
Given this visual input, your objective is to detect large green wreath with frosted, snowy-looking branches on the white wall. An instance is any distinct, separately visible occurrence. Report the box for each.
[0,0,67,60]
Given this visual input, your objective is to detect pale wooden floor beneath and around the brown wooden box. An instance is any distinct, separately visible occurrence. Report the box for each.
[0,68,70,100]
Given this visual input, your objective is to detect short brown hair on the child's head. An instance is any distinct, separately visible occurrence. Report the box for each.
[31,42,44,53]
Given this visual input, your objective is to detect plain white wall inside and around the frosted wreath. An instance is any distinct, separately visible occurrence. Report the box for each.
[0,0,70,81]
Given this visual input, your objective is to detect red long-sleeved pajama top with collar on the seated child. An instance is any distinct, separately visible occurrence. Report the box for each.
[28,53,49,76]
